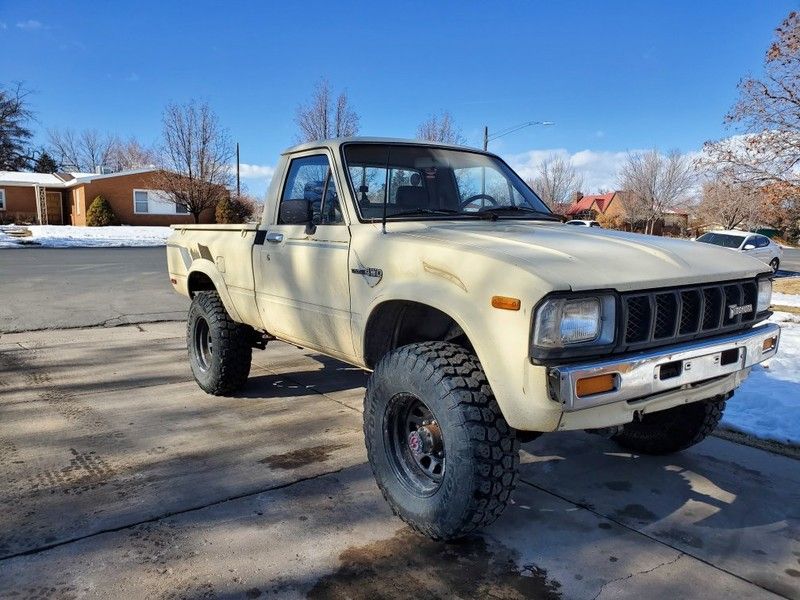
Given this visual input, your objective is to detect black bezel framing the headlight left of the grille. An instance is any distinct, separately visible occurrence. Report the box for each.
[528,289,621,364]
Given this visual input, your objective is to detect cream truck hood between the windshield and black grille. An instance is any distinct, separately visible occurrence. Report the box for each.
[404,220,770,291]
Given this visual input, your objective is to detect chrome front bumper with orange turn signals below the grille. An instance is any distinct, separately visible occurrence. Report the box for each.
[548,323,781,411]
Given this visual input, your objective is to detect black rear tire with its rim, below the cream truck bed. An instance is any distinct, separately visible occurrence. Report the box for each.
[186,292,253,396]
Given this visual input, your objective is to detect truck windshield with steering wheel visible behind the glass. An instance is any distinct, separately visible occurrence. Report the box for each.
[344,144,559,221]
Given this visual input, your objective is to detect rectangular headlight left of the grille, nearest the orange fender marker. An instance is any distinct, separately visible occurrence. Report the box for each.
[533,295,615,348]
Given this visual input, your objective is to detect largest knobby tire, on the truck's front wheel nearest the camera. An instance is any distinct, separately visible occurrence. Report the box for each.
[364,342,519,540]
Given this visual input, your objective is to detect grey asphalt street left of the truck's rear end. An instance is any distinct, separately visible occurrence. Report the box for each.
[0,247,188,331]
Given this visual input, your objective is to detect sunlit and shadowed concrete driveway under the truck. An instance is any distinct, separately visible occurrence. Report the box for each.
[0,323,800,599]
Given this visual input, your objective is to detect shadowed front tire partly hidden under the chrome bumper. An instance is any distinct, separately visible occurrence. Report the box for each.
[612,396,730,454]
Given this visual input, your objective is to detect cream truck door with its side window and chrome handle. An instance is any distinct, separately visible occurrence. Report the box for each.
[253,151,354,356]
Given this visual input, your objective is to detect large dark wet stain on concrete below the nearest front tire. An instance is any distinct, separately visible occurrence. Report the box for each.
[308,529,561,600]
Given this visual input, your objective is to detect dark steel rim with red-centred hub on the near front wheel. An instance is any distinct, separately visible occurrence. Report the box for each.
[383,394,446,496]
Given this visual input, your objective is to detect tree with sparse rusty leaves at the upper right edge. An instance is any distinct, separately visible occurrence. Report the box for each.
[704,12,800,188]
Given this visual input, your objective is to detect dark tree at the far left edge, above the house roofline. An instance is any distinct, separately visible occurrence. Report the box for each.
[0,84,33,171]
